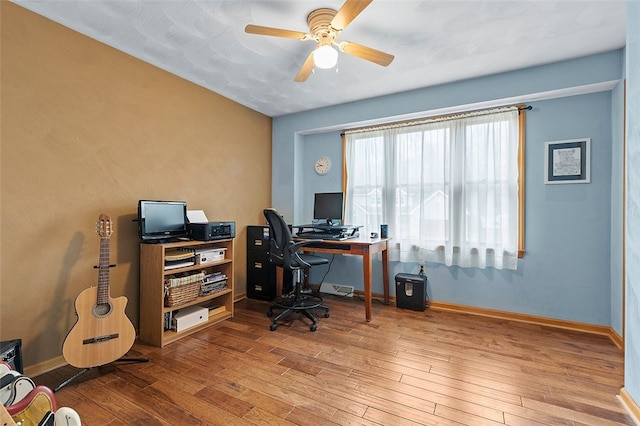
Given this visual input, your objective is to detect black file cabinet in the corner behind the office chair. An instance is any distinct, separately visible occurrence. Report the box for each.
[247,225,276,300]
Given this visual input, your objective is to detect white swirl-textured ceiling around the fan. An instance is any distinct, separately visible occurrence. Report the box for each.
[13,0,626,117]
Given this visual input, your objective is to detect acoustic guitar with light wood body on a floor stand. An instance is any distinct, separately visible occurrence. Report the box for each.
[62,214,136,368]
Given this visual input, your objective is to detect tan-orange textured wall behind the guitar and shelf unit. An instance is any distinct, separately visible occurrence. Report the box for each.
[0,1,271,372]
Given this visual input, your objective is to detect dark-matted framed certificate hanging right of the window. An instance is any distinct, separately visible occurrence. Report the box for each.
[544,138,591,184]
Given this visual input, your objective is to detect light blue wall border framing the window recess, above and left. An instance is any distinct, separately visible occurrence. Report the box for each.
[272,51,621,223]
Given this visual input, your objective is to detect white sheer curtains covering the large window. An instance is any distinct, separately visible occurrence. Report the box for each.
[345,108,519,270]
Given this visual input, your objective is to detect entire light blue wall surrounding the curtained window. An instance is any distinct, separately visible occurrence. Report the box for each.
[273,51,622,326]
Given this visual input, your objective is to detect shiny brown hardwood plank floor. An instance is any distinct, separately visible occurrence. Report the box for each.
[35,296,634,426]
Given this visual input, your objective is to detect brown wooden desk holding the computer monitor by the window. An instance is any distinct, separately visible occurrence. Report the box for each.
[302,237,389,321]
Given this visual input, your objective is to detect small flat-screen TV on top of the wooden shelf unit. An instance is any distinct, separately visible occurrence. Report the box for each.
[138,200,189,242]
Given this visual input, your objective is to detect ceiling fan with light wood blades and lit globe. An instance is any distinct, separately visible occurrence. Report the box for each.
[244,0,394,82]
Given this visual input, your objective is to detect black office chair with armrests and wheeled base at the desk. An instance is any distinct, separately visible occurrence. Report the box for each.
[264,209,329,331]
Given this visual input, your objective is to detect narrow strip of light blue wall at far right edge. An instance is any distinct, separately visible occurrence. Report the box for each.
[624,1,640,404]
